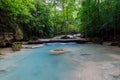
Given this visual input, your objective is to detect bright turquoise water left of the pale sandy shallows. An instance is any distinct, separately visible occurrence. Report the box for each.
[0,44,80,80]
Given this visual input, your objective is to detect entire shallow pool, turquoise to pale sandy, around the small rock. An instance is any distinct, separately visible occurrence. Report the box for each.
[0,43,120,80]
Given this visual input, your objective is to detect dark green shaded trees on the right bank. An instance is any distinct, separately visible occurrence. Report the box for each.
[77,0,120,40]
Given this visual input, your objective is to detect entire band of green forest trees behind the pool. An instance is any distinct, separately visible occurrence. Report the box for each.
[0,0,120,40]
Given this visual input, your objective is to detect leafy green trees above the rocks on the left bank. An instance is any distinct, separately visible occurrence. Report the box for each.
[0,0,51,39]
